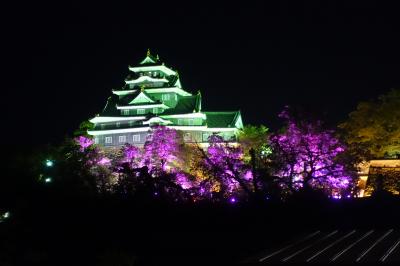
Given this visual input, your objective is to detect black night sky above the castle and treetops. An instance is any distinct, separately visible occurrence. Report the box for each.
[2,1,400,146]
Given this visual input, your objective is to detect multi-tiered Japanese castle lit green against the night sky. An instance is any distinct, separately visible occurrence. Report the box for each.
[88,51,243,147]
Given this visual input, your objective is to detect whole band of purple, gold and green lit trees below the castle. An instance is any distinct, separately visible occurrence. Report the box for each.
[32,104,376,203]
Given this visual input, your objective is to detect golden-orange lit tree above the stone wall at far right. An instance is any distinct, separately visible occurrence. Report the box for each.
[339,89,400,158]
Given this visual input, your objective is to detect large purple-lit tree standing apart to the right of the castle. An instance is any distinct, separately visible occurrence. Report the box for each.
[271,111,353,195]
